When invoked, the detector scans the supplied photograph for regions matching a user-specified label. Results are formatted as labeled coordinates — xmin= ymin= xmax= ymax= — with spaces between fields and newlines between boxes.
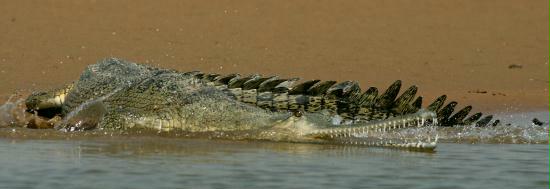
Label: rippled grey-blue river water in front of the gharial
xmin=0 ymin=137 xmax=548 ymax=188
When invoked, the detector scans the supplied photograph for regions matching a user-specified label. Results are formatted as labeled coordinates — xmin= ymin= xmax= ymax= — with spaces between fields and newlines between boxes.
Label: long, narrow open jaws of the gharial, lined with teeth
xmin=294 ymin=111 xmax=438 ymax=151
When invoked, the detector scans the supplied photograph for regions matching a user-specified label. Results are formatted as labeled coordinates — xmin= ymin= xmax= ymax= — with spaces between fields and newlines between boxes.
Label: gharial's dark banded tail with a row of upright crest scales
xmin=201 ymin=74 xmax=498 ymax=126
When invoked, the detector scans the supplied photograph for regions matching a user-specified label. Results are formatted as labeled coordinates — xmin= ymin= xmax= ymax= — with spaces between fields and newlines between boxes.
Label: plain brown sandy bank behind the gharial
xmin=0 ymin=0 xmax=550 ymax=112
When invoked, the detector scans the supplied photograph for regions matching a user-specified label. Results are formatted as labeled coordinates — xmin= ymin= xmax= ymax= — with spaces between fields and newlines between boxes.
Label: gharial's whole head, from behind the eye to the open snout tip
xmin=259 ymin=110 xmax=437 ymax=151
